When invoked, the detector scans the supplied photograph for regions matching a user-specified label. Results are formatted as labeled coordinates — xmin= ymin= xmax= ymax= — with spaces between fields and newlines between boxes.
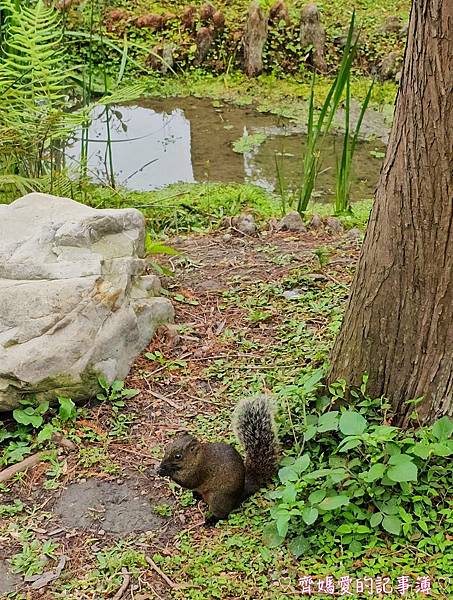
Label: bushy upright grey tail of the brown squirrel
xmin=233 ymin=396 xmax=278 ymax=498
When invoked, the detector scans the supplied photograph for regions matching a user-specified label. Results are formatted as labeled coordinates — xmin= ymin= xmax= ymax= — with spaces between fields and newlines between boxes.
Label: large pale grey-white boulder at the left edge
xmin=0 ymin=194 xmax=173 ymax=410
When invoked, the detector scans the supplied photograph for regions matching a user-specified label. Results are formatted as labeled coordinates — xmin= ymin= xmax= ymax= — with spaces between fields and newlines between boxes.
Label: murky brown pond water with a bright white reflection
xmin=66 ymin=98 xmax=385 ymax=200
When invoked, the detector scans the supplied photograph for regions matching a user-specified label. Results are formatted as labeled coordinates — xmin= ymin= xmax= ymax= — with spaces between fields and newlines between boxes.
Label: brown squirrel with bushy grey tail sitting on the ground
xmin=158 ymin=396 xmax=278 ymax=527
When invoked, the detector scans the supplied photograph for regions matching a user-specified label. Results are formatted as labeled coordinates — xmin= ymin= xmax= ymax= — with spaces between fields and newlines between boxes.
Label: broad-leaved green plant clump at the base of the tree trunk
xmin=266 ymin=375 xmax=453 ymax=551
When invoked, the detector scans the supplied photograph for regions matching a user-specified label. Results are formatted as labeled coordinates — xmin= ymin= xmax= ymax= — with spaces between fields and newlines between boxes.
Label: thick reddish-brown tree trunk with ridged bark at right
xmin=329 ymin=0 xmax=453 ymax=426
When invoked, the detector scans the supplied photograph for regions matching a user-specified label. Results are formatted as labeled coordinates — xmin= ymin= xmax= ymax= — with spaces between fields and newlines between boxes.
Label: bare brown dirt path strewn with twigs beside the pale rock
xmin=0 ymin=229 xmax=360 ymax=600
